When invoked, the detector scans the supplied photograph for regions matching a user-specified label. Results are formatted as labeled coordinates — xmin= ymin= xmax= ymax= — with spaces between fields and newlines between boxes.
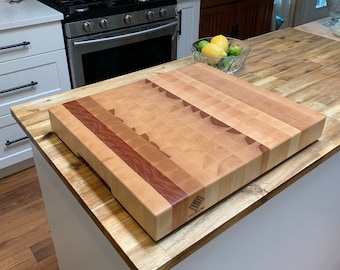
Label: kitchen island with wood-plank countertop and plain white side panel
xmin=12 ymin=28 xmax=340 ymax=269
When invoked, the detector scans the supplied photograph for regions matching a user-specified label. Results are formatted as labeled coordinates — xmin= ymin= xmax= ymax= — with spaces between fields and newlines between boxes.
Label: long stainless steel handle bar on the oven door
xmin=73 ymin=21 xmax=177 ymax=47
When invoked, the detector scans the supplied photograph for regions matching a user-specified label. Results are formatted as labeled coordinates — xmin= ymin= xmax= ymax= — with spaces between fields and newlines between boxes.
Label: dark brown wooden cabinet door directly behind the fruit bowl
xmin=199 ymin=4 xmax=236 ymax=37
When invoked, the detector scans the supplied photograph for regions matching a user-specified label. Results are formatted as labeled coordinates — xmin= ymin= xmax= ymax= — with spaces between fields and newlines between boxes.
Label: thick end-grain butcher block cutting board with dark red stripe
xmin=49 ymin=63 xmax=325 ymax=240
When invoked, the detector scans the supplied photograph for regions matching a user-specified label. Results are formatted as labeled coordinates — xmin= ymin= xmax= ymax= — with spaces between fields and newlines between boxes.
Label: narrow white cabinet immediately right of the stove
xmin=177 ymin=0 xmax=200 ymax=59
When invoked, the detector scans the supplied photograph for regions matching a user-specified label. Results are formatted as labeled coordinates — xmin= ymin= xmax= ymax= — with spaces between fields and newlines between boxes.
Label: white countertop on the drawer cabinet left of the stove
xmin=0 ymin=0 xmax=63 ymax=31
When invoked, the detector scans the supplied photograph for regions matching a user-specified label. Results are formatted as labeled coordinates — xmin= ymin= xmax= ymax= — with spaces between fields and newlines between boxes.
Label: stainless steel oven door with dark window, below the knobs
xmin=66 ymin=18 xmax=177 ymax=88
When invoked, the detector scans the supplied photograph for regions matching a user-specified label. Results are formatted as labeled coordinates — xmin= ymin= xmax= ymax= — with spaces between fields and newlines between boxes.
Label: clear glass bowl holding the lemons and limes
xmin=191 ymin=37 xmax=251 ymax=74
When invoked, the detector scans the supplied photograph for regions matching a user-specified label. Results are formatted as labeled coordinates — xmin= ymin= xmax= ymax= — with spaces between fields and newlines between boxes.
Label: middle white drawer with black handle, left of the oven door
xmin=0 ymin=50 xmax=70 ymax=116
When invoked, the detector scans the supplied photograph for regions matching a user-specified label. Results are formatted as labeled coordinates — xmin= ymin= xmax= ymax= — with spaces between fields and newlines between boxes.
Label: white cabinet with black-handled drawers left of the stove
xmin=0 ymin=21 xmax=71 ymax=178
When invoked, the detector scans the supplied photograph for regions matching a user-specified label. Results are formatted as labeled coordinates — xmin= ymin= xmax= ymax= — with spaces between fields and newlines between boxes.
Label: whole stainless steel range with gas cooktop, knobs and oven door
xmin=40 ymin=0 xmax=177 ymax=88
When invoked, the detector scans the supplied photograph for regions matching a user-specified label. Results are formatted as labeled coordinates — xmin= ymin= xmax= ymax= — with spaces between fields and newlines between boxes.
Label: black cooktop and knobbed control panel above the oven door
xmin=39 ymin=0 xmax=177 ymax=38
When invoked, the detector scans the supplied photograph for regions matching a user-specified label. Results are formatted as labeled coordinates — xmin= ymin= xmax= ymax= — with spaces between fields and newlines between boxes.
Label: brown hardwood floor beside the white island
xmin=0 ymin=167 xmax=58 ymax=270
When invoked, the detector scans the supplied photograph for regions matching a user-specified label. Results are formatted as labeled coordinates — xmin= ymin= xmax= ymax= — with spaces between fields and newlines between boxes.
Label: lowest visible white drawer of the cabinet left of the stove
xmin=0 ymin=115 xmax=32 ymax=169
